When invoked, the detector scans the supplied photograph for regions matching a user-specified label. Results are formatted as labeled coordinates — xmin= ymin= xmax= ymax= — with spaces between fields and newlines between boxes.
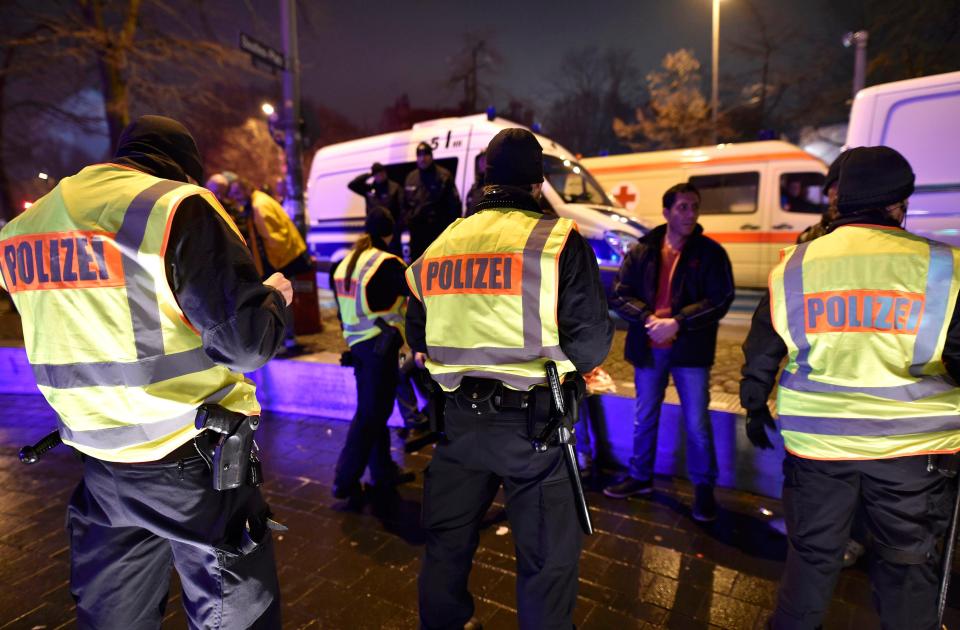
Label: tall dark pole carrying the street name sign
xmin=280 ymin=0 xmax=307 ymax=236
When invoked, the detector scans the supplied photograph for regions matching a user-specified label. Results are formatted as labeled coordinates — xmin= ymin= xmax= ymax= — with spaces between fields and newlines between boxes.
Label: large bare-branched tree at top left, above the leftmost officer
xmin=0 ymin=0 xmax=266 ymax=217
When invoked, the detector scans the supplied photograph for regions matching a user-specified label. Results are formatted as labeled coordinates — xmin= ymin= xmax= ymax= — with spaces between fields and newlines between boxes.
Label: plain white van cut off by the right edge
xmin=847 ymin=72 xmax=960 ymax=247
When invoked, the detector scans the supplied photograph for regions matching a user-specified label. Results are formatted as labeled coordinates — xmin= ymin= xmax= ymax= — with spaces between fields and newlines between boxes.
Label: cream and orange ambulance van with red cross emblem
xmin=582 ymin=140 xmax=827 ymax=288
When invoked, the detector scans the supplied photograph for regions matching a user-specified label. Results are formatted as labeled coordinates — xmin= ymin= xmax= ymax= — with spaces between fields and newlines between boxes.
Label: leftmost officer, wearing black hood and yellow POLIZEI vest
xmin=0 ymin=116 xmax=292 ymax=629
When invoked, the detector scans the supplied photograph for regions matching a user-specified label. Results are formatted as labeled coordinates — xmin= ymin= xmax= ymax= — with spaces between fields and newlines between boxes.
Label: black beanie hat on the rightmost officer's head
xmin=837 ymin=146 xmax=915 ymax=214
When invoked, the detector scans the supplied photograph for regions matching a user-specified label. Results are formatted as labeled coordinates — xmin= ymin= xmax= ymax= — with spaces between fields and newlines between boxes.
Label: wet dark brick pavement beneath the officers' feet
xmin=0 ymin=396 xmax=960 ymax=630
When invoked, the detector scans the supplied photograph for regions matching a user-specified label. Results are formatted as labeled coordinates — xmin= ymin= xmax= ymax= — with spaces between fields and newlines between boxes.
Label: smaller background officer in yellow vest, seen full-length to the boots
xmin=333 ymin=206 xmax=409 ymax=509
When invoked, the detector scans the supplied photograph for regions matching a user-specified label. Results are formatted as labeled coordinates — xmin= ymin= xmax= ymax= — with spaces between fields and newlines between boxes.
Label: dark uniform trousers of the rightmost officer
xmin=771 ymin=454 xmax=954 ymax=630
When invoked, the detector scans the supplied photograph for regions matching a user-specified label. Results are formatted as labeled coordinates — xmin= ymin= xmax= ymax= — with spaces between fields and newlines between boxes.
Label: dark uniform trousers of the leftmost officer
xmin=67 ymin=457 xmax=280 ymax=630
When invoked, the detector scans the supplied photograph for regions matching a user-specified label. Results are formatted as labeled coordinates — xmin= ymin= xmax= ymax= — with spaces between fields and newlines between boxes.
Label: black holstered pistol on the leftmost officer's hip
xmin=194 ymin=405 xmax=263 ymax=491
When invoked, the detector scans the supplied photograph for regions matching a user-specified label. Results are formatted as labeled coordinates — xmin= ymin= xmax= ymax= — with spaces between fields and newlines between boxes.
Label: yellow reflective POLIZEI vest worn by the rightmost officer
xmin=770 ymin=225 xmax=960 ymax=460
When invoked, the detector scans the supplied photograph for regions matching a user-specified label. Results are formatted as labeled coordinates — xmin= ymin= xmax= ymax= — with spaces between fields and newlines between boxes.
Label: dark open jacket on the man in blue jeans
xmin=610 ymin=225 xmax=734 ymax=367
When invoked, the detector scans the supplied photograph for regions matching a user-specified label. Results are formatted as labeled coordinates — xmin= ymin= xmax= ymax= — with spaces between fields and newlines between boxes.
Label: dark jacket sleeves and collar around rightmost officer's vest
xmin=740 ymin=217 xmax=960 ymax=411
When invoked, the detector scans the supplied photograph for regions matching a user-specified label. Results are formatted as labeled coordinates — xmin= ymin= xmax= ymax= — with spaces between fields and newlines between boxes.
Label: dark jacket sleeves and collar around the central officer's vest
xmin=407 ymin=186 xmax=613 ymax=374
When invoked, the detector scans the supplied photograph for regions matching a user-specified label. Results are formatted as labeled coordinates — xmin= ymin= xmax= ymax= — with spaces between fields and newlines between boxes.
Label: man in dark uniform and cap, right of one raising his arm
xmin=403 ymin=142 xmax=461 ymax=262
